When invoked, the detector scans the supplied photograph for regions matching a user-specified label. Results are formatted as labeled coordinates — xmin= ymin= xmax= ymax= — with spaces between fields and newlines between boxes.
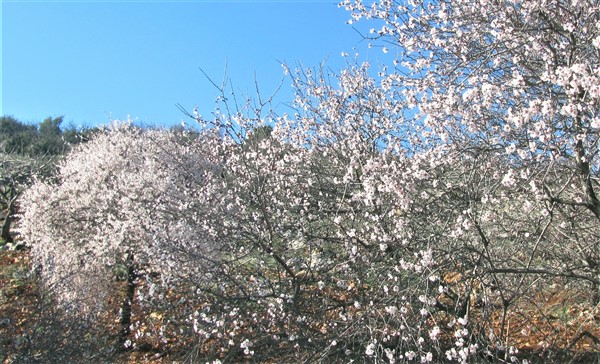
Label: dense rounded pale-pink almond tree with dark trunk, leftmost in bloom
xmin=19 ymin=123 xmax=223 ymax=347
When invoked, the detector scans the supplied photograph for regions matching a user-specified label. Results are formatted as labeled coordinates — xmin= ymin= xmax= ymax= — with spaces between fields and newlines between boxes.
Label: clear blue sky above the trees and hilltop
xmin=0 ymin=0 xmax=381 ymax=129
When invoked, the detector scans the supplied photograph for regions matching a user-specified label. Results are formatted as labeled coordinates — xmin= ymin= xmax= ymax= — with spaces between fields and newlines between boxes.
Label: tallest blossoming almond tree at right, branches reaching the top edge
xmin=341 ymin=0 xmax=600 ymax=356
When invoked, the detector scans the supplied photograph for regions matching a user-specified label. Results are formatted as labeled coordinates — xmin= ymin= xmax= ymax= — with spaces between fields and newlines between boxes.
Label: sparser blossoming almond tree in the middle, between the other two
xmin=176 ymin=67 xmax=477 ymax=361
